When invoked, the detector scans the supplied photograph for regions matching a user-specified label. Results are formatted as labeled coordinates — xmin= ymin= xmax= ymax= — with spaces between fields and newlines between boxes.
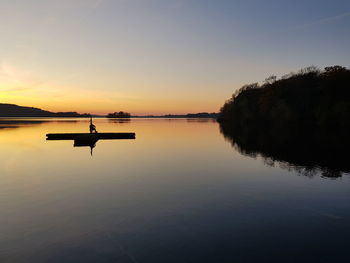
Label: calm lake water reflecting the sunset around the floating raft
xmin=0 ymin=119 xmax=350 ymax=262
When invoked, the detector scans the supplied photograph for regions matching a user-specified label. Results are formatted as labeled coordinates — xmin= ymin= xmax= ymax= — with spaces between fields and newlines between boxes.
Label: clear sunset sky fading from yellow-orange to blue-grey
xmin=0 ymin=0 xmax=350 ymax=115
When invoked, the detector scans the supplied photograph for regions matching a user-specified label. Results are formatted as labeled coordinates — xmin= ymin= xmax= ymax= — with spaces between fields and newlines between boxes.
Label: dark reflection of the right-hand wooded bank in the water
xmin=220 ymin=124 xmax=350 ymax=178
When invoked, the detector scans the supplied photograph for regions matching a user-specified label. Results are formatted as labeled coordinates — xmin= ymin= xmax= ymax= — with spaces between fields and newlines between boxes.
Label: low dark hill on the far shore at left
xmin=0 ymin=103 xmax=90 ymax=117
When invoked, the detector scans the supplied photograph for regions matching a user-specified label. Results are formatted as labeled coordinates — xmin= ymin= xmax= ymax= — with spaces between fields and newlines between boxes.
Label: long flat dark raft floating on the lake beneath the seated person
xmin=46 ymin=132 xmax=135 ymax=141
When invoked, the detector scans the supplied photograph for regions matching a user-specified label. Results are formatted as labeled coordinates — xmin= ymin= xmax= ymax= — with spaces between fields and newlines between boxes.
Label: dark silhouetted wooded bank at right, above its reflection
xmin=218 ymin=66 xmax=350 ymax=136
